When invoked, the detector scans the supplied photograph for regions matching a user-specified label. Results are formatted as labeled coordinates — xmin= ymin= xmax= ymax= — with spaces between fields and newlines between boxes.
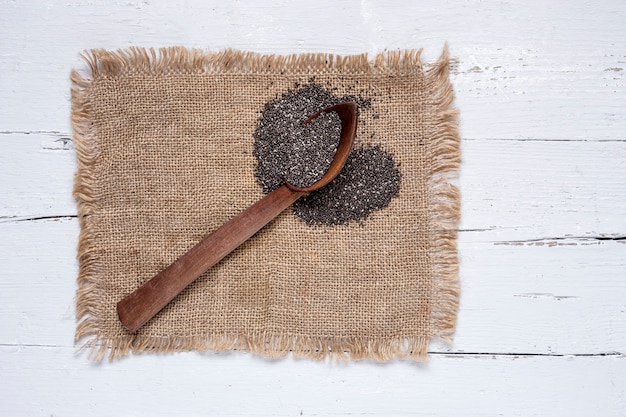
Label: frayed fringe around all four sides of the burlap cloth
xmin=71 ymin=46 xmax=460 ymax=361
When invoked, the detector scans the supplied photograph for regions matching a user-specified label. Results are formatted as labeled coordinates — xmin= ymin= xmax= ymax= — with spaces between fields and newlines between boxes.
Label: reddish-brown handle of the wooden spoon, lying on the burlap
xmin=117 ymin=185 xmax=305 ymax=332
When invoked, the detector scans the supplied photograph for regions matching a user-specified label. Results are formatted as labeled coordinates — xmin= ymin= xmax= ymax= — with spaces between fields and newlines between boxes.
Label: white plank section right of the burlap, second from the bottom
xmin=454 ymin=232 xmax=626 ymax=354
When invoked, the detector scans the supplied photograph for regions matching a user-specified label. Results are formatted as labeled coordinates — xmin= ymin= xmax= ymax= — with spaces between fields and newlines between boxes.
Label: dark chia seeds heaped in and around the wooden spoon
xmin=254 ymin=81 xmax=400 ymax=225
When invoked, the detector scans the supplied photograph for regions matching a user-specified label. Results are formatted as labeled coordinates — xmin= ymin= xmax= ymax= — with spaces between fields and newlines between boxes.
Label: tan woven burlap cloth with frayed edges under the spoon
xmin=72 ymin=44 xmax=459 ymax=360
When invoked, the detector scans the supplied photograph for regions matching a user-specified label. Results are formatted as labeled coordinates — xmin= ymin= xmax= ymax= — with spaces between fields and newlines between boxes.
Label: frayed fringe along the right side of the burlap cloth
xmin=425 ymin=45 xmax=461 ymax=343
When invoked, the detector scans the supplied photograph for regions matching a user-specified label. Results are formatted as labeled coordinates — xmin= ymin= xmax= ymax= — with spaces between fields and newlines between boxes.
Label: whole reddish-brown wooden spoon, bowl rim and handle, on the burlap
xmin=117 ymin=102 xmax=358 ymax=332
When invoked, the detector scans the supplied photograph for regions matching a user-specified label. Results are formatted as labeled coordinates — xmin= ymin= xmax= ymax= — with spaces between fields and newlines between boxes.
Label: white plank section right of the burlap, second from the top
xmin=460 ymin=141 xmax=626 ymax=241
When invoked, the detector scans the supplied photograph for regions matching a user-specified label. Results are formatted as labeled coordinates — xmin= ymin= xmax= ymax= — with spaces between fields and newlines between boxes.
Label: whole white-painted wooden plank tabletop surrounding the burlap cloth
xmin=0 ymin=0 xmax=626 ymax=417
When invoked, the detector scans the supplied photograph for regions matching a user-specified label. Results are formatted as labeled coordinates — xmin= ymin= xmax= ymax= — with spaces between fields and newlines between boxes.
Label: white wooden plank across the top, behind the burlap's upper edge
xmin=0 ymin=0 xmax=626 ymax=141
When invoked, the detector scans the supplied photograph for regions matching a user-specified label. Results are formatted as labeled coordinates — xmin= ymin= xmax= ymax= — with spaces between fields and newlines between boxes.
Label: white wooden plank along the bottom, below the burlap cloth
xmin=0 ymin=346 xmax=626 ymax=417
